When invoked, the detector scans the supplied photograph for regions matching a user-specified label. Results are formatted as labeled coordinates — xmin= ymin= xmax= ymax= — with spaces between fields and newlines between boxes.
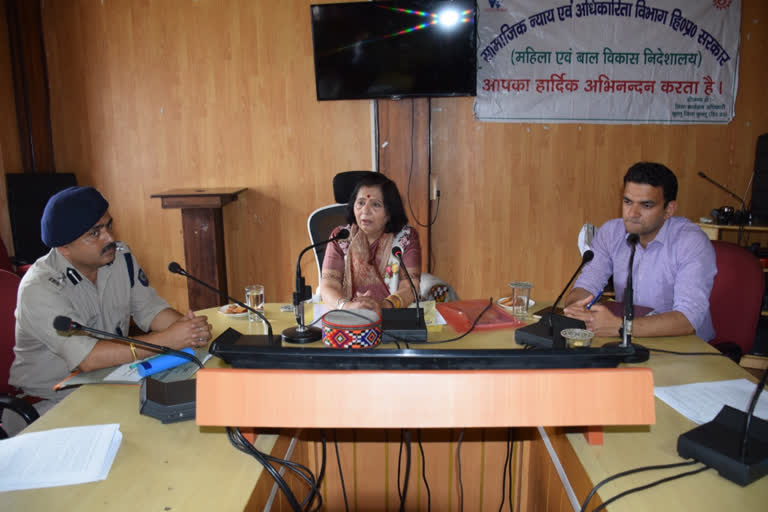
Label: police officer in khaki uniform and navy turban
xmin=9 ymin=187 xmax=211 ymax=418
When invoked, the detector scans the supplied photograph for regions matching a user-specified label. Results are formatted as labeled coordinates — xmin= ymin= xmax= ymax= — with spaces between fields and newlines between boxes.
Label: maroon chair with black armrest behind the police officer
xmin=0 ymin=270 xmax=40 ymax=439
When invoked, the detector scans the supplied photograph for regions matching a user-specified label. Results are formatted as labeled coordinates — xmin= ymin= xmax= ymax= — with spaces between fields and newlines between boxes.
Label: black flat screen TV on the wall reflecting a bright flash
xmin=311 ymin=0 xmax=477 ymax=100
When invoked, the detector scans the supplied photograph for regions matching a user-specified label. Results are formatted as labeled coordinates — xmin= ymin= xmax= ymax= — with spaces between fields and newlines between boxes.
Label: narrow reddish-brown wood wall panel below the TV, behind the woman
xmin=376 ymin=98 xmax=432 ymax=272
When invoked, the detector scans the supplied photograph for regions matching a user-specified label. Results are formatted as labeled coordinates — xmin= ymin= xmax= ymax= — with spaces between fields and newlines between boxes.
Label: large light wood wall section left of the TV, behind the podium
xmin=42 ymin=0 xmax=372 ymax=309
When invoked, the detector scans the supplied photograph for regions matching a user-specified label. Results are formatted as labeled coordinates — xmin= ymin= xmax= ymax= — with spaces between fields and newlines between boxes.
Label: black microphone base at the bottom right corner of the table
xmin=677 ymin=405 xmax=768 ymax=486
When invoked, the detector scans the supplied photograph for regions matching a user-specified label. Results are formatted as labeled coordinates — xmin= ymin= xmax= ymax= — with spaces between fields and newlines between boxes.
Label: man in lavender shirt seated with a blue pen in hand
xmin=565 ymin=162 xmax=717 ymax=341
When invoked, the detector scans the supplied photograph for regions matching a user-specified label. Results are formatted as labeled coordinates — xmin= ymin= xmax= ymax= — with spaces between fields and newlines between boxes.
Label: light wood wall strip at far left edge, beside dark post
xmin=0 ymin=3 xmax=23 ymax=254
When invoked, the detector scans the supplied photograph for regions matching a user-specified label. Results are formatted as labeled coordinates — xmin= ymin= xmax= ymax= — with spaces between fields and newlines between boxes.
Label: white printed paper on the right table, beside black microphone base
xmin=654 ymin=379 xmax=768 ymax=425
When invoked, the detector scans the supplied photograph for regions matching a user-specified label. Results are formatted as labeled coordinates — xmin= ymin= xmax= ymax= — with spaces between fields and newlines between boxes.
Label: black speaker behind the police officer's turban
xmin=6 ymin=173 xmax=77 ymax=264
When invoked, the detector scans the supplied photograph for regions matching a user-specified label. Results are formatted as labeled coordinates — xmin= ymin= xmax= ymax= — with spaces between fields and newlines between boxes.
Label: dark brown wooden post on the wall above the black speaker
xmin=5 ymin=0 xmax=55 ymax=172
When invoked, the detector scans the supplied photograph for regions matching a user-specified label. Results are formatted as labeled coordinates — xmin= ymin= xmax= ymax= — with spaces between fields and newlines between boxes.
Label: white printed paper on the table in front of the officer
xmin=0 ymin=423 xmax=123 ymax=492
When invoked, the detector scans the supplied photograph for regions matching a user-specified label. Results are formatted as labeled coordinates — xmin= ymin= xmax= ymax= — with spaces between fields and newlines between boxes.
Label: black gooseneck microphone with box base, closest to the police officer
xmin=53 ymin=316 xmax=203 ymax=423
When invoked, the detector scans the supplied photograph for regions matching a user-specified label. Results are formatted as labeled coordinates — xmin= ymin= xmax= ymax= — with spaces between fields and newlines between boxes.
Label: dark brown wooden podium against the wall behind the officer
xmin=150 ymin=188 xmax=247 ymax=311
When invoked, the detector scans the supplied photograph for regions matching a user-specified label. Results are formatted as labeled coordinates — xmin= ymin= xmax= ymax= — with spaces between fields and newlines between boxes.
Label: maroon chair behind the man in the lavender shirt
xmin=709 ymin=240 xmax=763 ymax=355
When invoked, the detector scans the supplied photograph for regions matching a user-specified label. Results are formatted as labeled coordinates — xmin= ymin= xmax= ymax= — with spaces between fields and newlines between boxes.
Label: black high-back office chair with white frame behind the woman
xmin=307 ymin=171 xmax=459 ymax=302
